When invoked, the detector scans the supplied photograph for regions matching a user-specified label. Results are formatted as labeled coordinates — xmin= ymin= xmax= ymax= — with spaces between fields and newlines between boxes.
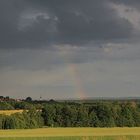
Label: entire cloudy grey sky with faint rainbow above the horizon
xmin=0 ymin=0 xmax=140 ymax=99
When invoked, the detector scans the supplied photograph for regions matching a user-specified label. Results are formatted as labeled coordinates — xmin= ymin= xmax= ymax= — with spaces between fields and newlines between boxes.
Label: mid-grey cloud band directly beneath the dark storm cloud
xmin=0 ymin=42 xmax=140 ymax=71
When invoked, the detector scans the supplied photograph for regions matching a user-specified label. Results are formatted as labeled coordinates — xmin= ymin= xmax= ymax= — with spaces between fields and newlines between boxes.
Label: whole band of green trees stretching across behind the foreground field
xmin=0 ymin=101 xmax=140 ymax=129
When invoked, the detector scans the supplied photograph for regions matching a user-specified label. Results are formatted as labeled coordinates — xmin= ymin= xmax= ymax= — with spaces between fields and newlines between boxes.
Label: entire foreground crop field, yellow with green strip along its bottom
xmin=0 ymin=128 xmax=140 ymax=140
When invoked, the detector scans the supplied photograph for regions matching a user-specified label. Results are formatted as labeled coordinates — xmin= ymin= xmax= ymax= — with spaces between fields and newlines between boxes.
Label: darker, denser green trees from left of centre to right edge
xmin=42 ymin=103 xmax=140 ymax=127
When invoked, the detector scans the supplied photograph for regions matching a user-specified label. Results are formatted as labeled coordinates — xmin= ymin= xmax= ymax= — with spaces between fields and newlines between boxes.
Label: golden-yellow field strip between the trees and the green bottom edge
xmin=0 ymin=128 xmax=140 ymax=137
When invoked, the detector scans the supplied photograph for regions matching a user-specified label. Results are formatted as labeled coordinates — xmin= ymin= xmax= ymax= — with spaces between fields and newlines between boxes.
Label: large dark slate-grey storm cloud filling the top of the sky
xmin=0 ymin=0 xmax=133 ymax=49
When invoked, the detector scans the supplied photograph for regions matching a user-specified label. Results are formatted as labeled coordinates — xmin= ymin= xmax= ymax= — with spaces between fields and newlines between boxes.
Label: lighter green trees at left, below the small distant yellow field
xmin=0 ymin=109 xmax=44 ymax=129
